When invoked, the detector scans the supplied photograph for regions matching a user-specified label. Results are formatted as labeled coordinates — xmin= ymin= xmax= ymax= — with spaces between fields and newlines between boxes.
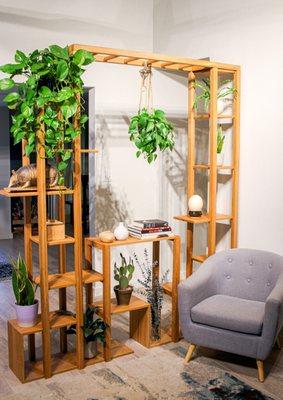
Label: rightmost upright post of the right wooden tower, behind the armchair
xmin=231 ymin=70 xmax=241 ymax=248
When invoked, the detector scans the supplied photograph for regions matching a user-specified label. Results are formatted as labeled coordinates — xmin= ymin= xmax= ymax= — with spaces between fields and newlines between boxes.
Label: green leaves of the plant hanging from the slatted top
xmin=129 ymin=108 xmax=175 ymax=164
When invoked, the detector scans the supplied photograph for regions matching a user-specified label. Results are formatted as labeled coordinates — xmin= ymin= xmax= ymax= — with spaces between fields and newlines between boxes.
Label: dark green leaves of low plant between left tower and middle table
xmin=66 ymin=306 xmax=107 ymax=343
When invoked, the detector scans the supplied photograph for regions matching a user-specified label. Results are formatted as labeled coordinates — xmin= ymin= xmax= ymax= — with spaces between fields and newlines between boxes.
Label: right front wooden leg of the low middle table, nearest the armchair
xmin=172 ymin=236 xmax=181 ymax=342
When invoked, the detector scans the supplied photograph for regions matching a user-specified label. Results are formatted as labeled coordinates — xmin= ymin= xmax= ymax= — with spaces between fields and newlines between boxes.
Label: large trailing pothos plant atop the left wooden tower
xmin=0 ymin=45 xmax=94 ymax=184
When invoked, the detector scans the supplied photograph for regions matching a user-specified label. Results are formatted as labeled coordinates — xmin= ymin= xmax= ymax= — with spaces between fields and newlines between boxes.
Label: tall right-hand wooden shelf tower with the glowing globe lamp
xmin=174 ymin=66 xmax=240 ymax=277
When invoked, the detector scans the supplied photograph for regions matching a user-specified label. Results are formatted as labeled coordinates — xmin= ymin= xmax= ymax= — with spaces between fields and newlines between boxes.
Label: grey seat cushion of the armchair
xmin=191 ymin=294 xmax=265 ymax=335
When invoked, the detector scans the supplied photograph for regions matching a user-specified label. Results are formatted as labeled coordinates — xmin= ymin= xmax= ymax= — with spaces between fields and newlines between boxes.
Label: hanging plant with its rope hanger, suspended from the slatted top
xmin=129 ymin=67 xmax=175 ymax=164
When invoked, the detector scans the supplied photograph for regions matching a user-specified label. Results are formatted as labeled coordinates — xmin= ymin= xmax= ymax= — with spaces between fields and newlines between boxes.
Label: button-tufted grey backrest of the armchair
xmin=206 ymin=249 xmax=283 ymax=301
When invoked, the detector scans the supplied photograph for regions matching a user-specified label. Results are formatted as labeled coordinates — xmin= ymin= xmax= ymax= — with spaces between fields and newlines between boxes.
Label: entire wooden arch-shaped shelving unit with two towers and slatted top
xmin=0 ymin=44 xmax=240 ymax=382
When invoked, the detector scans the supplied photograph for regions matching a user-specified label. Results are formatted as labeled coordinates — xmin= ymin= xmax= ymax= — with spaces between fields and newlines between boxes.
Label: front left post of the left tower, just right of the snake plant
xmin=36 ymin=111 xmax=52 ymax=378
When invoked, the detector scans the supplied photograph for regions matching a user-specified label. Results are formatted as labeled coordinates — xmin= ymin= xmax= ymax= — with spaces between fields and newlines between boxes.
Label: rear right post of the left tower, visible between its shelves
xmin=58 ymin=195 xmax=68 ymax=353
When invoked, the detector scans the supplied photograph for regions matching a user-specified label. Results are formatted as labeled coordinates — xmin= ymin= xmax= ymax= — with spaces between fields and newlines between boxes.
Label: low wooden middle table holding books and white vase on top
xmin=85 ymin=235 xmax=180 ymax=361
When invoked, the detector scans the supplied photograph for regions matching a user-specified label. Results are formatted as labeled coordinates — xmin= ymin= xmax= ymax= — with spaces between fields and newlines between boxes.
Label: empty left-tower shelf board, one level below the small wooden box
xmin=34 ymin=270 xmax=103 ymax=289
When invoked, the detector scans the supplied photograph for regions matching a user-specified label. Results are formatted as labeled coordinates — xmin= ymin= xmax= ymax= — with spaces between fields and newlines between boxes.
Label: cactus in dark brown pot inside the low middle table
xmin=114 ymin=253 xmax=135 ymax=305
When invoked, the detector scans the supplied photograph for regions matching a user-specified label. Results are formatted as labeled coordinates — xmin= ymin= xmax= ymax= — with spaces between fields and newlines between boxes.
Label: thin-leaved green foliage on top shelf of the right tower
xmin=193 ymin=78 xmax=236 ymax=110
